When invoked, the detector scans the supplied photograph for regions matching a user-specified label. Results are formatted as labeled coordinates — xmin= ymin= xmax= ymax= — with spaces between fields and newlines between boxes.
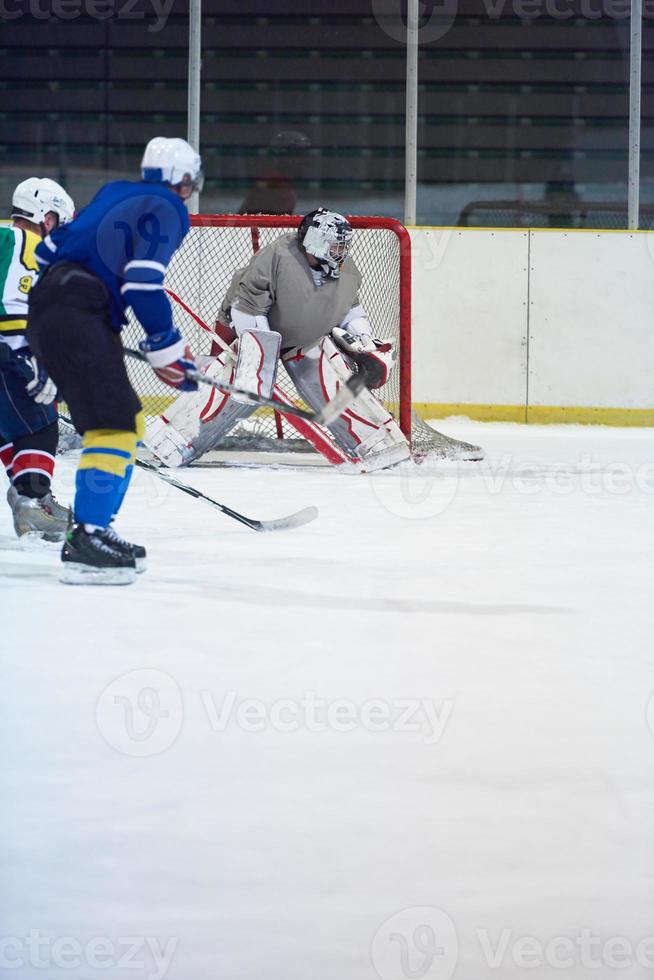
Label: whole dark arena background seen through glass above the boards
xmin=0 ymin=0 xmax=654 ymax=228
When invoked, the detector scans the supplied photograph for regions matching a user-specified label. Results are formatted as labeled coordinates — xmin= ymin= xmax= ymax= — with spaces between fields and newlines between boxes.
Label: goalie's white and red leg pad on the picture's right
xmin=284 ymin=337 xmax=411 ymax=472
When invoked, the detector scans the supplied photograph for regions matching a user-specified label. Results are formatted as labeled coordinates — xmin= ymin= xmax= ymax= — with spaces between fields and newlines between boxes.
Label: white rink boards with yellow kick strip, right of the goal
xmin=411 ymin=228 xmax=654 ymax=425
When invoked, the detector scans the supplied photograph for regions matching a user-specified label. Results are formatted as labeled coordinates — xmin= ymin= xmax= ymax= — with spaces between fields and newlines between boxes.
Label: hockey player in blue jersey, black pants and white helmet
xmin=28 ymin=137 xmax=202 ymax=585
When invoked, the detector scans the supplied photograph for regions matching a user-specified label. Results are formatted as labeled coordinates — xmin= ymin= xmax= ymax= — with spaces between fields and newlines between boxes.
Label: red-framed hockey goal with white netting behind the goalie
xmin=125 ymin=215 xmax=440 ymax=455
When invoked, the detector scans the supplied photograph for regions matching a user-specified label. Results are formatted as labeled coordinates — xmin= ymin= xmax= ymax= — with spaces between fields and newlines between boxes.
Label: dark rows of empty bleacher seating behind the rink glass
xmin=0 ymin=0 xmax=654 ymax=223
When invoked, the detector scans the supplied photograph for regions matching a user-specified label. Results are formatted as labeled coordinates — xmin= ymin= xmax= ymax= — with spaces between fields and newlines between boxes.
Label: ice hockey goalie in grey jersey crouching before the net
xmin=145 ymin=208 xmax=410 ymax=472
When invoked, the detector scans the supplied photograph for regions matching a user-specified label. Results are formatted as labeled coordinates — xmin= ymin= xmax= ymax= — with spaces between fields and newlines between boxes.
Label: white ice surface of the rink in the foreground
xmin=0 ymin=422 xmax=654 ymax=980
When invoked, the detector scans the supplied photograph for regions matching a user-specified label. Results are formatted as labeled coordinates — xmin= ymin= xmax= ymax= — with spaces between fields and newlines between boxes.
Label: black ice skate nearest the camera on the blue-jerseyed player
xmin=59 ymin=524 xmax=136 ymax=585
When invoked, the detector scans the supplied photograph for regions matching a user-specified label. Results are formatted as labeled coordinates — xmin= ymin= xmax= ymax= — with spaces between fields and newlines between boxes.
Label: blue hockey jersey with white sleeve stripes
xmin=35 ymin=180 xmax=189 ymax=334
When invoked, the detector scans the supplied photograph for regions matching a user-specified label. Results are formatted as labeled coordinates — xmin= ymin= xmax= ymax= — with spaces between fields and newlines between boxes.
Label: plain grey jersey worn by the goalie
xmin=220 ymin=233 xmax=361 ymax=348
